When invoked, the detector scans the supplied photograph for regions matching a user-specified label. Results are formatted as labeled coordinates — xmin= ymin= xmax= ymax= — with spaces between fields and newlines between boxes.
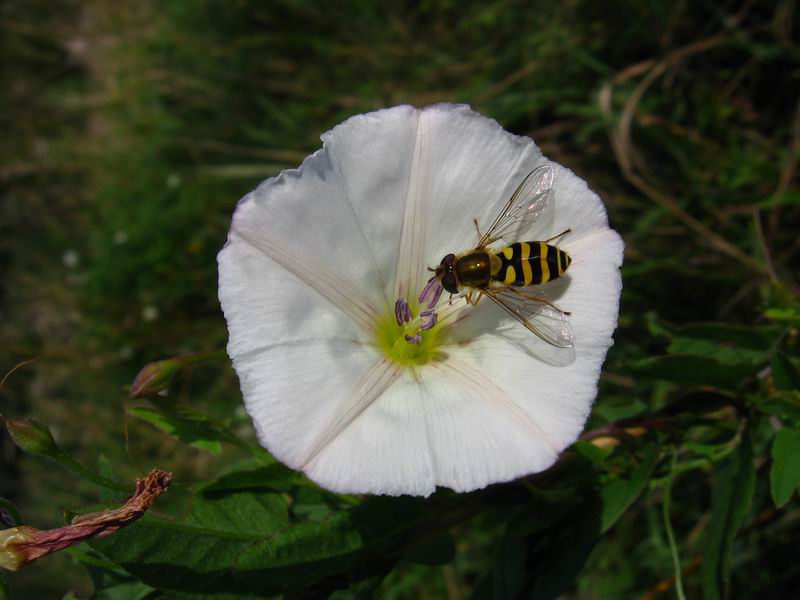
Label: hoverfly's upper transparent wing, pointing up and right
xmin=477 ymin=165 xmax=553 ymax=248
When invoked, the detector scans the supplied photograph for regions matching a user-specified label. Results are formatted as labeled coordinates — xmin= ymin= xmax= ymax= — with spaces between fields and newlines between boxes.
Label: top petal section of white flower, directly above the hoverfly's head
xmin=397 ymin=104 xmax=544 ymax=290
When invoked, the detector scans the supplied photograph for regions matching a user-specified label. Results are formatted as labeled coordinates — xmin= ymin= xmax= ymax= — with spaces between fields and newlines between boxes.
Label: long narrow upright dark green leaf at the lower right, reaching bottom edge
xmin=702 ymin=432 xmax=756 ymax=600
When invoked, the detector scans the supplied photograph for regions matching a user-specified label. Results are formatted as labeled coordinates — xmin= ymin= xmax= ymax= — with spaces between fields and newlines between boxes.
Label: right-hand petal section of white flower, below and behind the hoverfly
xmin=434 ymin=183 xmax=623 ymax=472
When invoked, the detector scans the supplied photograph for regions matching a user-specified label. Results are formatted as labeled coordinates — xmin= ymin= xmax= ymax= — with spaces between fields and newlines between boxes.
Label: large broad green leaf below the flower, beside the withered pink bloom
xmin=90 ymin=470 xmax=435 ymax=598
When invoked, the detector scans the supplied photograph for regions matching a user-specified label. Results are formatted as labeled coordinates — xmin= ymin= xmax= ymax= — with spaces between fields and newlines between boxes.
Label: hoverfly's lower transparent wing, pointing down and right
xmin=482 ymin=288 xmax=575 ymax=348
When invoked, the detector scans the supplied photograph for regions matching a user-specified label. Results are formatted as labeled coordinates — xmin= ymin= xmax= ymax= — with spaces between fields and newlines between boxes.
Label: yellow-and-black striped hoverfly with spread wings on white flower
xmin=428 ymin=165 xmax=573 ymax=348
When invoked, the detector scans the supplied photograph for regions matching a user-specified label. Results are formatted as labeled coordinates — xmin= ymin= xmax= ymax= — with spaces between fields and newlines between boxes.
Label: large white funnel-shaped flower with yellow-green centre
xmin=219 ymin=105 xmax=622 ymax=495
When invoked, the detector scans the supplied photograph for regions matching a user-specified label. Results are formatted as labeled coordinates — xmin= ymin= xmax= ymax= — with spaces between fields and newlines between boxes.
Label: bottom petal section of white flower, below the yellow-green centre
xmin=307 ymin=360 xmax=556 ymax=496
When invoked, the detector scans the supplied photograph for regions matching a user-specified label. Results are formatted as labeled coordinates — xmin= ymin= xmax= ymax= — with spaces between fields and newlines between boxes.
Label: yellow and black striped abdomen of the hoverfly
xmin=491 ymin=242 xmax=572 ymax=286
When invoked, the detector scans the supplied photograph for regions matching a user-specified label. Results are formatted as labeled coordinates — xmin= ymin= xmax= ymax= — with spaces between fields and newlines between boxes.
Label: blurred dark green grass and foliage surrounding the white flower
xmin=0 ymin=0 xmax=800 ymax=598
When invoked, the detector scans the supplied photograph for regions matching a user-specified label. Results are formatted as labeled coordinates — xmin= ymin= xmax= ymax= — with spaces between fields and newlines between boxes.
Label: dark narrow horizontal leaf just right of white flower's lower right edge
xmin=628 ymin=355 xmax=758 ymax=389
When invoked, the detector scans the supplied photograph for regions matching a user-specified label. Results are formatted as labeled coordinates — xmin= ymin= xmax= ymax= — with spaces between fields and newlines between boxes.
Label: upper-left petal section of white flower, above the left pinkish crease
xmin=219 ymin=146 xmax=388 ymax=328
